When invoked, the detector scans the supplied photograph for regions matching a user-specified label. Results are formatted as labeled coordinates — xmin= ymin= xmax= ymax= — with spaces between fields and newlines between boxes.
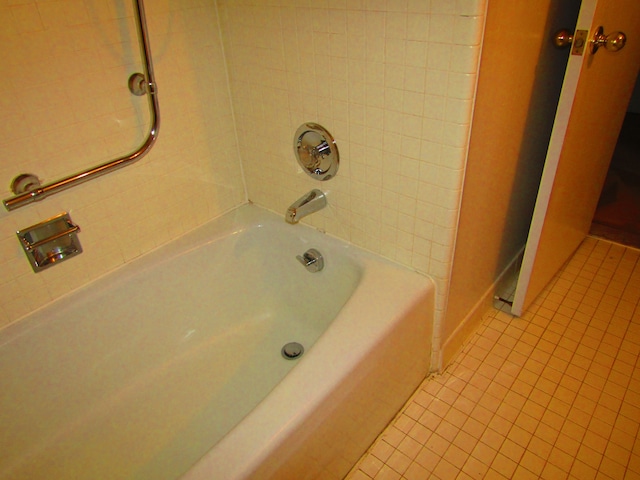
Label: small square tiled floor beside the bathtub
xmin=347 ymin=238 xmax=640 ymax=480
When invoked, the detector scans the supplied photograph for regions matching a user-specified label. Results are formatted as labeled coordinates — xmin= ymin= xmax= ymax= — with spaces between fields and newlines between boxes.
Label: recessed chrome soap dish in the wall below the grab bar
xmin=16 ymin=212 xmax=82 ymax=273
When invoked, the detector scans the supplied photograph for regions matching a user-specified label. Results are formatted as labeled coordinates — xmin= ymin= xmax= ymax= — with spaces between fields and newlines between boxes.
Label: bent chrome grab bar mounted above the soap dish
xmin=2 ymin=0 xmax=160 ymax=211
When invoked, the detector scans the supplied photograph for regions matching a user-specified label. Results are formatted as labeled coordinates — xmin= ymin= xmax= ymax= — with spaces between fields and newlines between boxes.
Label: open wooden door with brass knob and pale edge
xmin=512 ymin=0 xmax=640 ymax=315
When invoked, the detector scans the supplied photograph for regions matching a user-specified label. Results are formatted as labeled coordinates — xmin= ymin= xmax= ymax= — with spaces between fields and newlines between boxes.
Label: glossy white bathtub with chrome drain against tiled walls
xmin=0 ymin=205 xmax=434 ymax=480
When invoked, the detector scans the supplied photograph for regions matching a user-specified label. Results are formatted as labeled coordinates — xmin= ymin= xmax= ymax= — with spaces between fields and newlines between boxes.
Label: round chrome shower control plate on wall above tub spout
xmin=293 ymin=123 xmax=340 ymax=180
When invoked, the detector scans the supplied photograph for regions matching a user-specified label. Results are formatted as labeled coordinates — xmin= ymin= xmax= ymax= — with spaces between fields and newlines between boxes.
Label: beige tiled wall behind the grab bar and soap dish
xmin=0 ymin=0 xmax=246 ymax=326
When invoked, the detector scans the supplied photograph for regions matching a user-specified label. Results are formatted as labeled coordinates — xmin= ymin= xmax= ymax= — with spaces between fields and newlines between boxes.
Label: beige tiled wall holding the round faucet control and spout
xmin=218 ymin=0 xmax=485 ymax=360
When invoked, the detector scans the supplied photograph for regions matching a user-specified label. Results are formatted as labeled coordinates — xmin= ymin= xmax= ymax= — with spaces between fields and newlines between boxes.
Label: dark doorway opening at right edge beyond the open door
xmin=589 ymin=76 xmax=640 ymax=248
